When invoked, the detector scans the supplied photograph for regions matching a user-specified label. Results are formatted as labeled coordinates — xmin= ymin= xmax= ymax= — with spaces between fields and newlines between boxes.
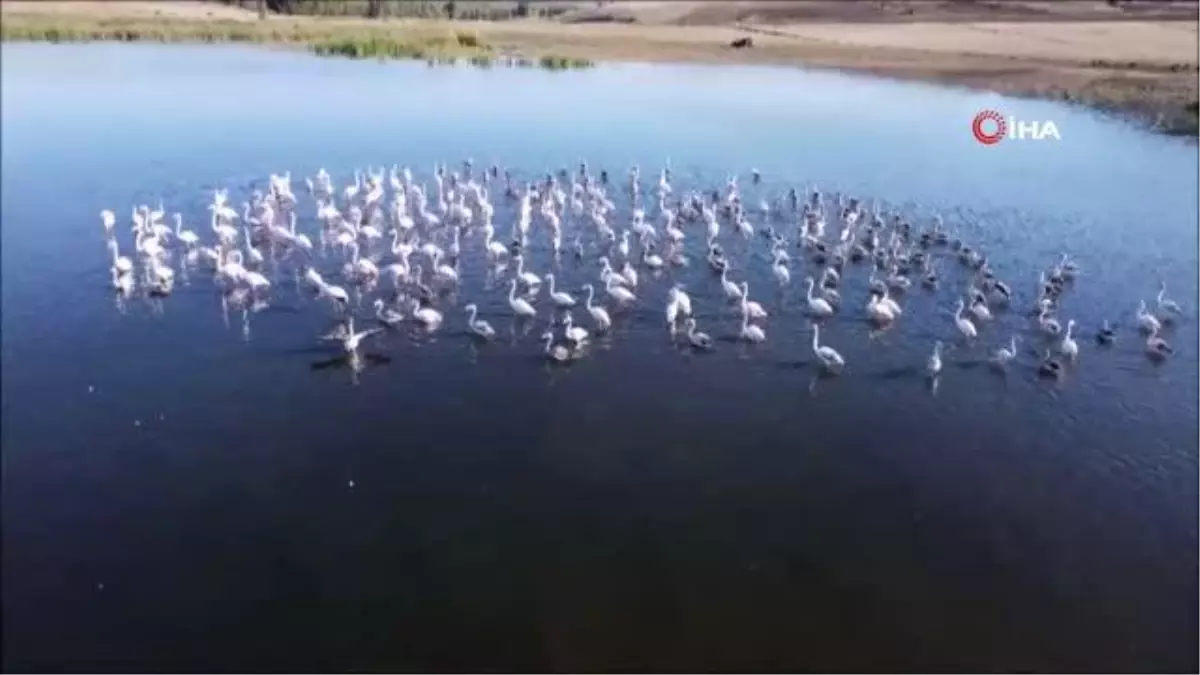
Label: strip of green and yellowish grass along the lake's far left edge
xmin=0 ymin=14 xmax=594 ymax=71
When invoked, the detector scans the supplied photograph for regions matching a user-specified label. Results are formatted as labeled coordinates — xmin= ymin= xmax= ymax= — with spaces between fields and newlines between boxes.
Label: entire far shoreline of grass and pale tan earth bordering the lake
xmin=0 ymin=1 xmax=1200 ymax=137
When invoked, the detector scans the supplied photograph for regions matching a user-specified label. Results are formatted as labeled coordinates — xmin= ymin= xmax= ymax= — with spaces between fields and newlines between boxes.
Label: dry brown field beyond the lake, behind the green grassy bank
xmin=7 ymin=0 xmax=1200 ymax=132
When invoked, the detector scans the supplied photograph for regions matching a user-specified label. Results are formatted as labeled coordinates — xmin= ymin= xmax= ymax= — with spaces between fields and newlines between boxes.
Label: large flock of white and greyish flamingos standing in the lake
xmin=101 ymin=160 xmax=1182 ymax=377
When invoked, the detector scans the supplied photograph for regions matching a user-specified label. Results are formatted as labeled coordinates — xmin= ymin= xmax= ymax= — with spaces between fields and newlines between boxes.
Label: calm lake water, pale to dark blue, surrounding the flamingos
xmin=0 ymin=44 xmax=1198 ymax=671
